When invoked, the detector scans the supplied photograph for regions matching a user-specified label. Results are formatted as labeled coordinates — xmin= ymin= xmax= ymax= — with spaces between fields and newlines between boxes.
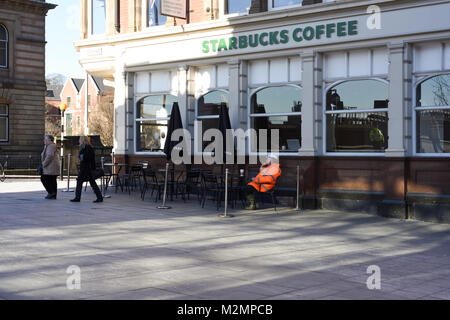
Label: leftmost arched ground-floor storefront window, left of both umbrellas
xmin=136 ymin=94 xmax=178 ymax=152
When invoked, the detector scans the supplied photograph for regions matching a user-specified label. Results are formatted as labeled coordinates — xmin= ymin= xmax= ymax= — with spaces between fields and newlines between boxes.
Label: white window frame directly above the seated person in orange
xmin=247 ymin=82 xmax=303 ymax=156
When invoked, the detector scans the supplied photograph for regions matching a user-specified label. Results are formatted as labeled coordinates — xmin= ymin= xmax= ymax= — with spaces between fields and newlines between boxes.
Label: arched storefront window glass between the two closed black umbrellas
xmin=197 ymin=90 xmax=230 ymax=149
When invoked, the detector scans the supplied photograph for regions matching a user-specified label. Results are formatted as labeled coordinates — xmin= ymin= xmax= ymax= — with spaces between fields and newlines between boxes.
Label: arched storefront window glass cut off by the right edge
xmin=415 ymin=74 xmax=450 ymax=153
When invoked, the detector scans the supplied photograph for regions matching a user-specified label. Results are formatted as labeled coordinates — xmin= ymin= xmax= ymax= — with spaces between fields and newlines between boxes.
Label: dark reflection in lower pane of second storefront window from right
xmin=327 ymin=112 xmax=388 ymax=152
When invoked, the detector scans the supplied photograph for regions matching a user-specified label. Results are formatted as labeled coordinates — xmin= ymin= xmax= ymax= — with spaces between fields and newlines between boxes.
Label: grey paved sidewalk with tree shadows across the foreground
xmin=0 ymin=180 xmax=450 ymax=300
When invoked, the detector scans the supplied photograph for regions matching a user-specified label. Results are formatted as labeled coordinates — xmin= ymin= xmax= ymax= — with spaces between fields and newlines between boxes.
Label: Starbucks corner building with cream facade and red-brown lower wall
xmin=75 ymin=0 xmax=450 ymax=222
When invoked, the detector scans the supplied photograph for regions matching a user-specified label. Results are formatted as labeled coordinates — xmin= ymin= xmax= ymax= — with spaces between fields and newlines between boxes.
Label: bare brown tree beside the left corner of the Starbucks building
xmin=89 ymin=94 xmax=114 ymax=146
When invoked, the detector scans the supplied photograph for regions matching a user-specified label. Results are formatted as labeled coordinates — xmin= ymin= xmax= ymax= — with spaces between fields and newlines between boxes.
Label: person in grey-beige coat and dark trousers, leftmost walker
xmin=41 ymin=134 xmax=59 ymax=199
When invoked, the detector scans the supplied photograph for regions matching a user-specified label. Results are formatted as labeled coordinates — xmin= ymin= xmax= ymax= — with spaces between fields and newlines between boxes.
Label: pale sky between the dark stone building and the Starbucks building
xmin=45 ymin=0 xmax=85 ymax=78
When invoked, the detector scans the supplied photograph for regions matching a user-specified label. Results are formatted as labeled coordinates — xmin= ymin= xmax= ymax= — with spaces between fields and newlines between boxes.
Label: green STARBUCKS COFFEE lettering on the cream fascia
xmin=202 ymin=20 xmax=358 ymax=53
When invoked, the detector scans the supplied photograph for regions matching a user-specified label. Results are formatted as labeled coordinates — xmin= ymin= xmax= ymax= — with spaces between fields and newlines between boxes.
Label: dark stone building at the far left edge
xmin=0 ymin=0 xmax=56 ymax=157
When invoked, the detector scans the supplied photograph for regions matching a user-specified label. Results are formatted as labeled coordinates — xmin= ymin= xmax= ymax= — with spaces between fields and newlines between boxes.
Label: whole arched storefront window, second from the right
xmin=325 ymin=80 xmax=389 ymax=152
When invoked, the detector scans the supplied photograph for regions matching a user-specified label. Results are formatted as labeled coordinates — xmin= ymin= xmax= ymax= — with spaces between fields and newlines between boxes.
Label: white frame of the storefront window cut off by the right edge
xmin=411 ymin=71 xmax=450 ymax=158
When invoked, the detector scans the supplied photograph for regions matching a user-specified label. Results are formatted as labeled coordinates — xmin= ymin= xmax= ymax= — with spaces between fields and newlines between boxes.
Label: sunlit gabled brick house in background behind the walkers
xmin=60 ymin=75 xmax=114 ymax=136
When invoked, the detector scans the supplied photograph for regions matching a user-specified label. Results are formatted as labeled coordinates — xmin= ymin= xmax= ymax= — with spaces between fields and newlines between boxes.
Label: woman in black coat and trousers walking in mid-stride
xmin=70 ymin=136 xmax=103 ymax=202
